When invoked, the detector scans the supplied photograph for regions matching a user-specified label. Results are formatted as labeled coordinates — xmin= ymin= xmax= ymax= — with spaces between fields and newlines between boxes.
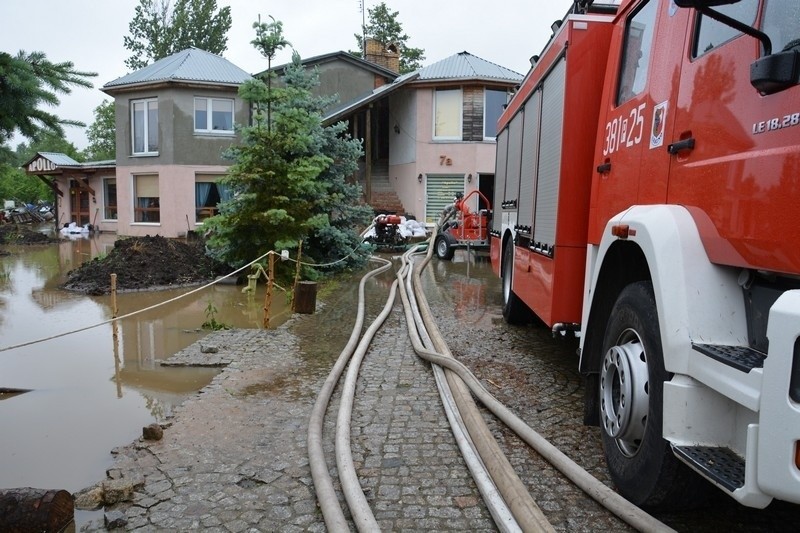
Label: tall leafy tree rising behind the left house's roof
xmin=123 ymin=0 xmax=231 ymax=70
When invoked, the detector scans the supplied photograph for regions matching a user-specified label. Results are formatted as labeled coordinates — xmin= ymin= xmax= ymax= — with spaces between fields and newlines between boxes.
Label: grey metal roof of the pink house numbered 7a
xmin=323 ymin=52 xmax=523 ymax=124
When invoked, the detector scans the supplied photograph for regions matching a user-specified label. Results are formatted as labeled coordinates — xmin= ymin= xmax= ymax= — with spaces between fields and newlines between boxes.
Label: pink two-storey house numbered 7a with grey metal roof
xmin=325 ymin=52 xmax=522 ymax=223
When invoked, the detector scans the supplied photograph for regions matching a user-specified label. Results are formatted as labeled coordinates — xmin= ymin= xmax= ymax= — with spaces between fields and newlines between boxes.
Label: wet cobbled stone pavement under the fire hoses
xmin=80 ymin=252 xmax=800 ymax=531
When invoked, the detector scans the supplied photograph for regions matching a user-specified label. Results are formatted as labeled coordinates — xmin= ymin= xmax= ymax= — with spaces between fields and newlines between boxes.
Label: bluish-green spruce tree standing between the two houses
xmin=204 ymin=20 xmax=371 ymax=275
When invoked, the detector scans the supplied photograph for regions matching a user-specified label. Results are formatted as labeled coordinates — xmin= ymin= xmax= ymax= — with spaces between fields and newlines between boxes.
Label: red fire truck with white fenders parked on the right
xmin=490 ymin=0 xmax=800 ymax=509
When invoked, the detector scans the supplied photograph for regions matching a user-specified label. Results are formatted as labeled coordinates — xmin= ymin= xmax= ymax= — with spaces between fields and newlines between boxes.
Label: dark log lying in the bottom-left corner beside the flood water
xmin=0 ymin=487 xmax=75 ymax=533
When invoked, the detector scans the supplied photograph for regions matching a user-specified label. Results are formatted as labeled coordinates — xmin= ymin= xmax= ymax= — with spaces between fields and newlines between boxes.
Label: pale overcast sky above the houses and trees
xmin=0 ymin=0 xmax=572 ymax=149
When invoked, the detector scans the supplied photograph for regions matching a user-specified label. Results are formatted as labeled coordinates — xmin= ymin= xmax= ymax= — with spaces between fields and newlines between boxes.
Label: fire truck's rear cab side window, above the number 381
xmin=617 ymin=2 xmax=658 ymax=105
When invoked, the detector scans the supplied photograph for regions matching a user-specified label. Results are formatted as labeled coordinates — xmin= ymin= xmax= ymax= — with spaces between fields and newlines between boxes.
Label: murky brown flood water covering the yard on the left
xmin=0 ymin=228 xmax=288 ymax=492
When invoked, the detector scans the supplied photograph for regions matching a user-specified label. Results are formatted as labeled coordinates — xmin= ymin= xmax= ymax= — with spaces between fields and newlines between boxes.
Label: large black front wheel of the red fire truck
xmin=598 ymin=282 xmax=709 ymax=510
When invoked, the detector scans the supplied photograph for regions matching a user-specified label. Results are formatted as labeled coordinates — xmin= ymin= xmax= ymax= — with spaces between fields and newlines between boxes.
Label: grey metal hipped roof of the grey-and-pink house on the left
xmin=103 ymin=47 xmax=252 ymax=92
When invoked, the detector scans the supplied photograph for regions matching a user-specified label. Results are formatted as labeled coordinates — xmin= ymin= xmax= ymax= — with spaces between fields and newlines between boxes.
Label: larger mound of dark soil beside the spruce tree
xmin=64 ymin=236 xmax=230 ymax=295
